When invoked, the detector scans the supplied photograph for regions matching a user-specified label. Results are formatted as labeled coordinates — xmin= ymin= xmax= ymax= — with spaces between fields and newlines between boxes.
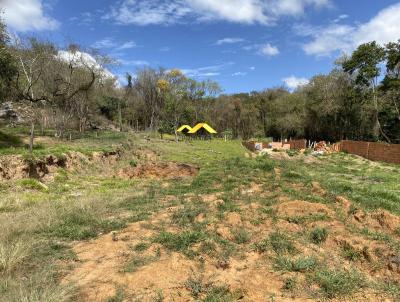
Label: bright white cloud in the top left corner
xmin=0 ymin=0 xmax=59 ymax=32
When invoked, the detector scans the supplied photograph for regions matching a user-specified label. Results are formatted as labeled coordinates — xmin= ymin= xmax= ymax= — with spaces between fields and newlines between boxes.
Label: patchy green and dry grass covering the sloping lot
xmin=0 ymin=129 xmax=400 ymax=302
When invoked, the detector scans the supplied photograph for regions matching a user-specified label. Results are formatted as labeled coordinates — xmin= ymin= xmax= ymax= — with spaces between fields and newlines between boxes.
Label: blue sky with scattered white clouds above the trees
xmin=0 ymin=0 xmax=400 ymax=93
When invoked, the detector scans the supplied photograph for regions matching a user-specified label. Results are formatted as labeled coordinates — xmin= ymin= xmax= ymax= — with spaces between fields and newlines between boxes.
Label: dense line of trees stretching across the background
xmin=0 ymin=22 xmax=400 ymax=143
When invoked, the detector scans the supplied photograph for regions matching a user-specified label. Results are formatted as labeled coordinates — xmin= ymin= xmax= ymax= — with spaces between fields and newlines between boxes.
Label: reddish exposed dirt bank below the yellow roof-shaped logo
xmin=117 ymin=162 xmax=199 ymax=179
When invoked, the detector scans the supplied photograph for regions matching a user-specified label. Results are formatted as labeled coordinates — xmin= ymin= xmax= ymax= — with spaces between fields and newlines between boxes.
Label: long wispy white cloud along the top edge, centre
xmin=104 ymin=0 xmax=330 ymax=25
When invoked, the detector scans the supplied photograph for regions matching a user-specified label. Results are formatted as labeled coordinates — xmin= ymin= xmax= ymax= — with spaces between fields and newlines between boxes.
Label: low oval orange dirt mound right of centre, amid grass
xmin=276 ymin=200 xmax=334 ymax=217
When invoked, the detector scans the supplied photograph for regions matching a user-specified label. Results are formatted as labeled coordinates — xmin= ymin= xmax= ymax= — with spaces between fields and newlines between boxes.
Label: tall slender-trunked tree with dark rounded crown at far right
xmin=343 ymin=41 xmax=390 ymax=142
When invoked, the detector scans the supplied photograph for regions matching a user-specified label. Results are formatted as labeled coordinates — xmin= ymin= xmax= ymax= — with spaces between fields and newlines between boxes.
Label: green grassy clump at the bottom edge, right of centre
xmin=314 ymin=269 xmax=365 ymax=299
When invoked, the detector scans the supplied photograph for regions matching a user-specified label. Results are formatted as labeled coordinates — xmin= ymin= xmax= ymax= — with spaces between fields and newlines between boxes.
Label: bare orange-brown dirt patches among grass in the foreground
xmin=64 ymin=180 xmax=400 ymax=302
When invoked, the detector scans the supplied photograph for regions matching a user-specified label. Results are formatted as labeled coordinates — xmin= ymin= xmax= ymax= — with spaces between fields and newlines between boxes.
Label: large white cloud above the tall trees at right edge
xmin=296 ymin=3 xmax=400 ymax=56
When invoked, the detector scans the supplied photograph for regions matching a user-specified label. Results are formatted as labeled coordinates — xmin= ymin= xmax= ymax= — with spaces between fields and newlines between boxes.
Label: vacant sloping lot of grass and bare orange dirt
xmin=0 ymin=131 xmax=400 ymax=302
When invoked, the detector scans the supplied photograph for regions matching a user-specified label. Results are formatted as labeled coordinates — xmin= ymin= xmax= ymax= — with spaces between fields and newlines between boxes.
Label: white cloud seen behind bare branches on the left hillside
xmin=57 ymin=50 xmax=115 ymax=78
